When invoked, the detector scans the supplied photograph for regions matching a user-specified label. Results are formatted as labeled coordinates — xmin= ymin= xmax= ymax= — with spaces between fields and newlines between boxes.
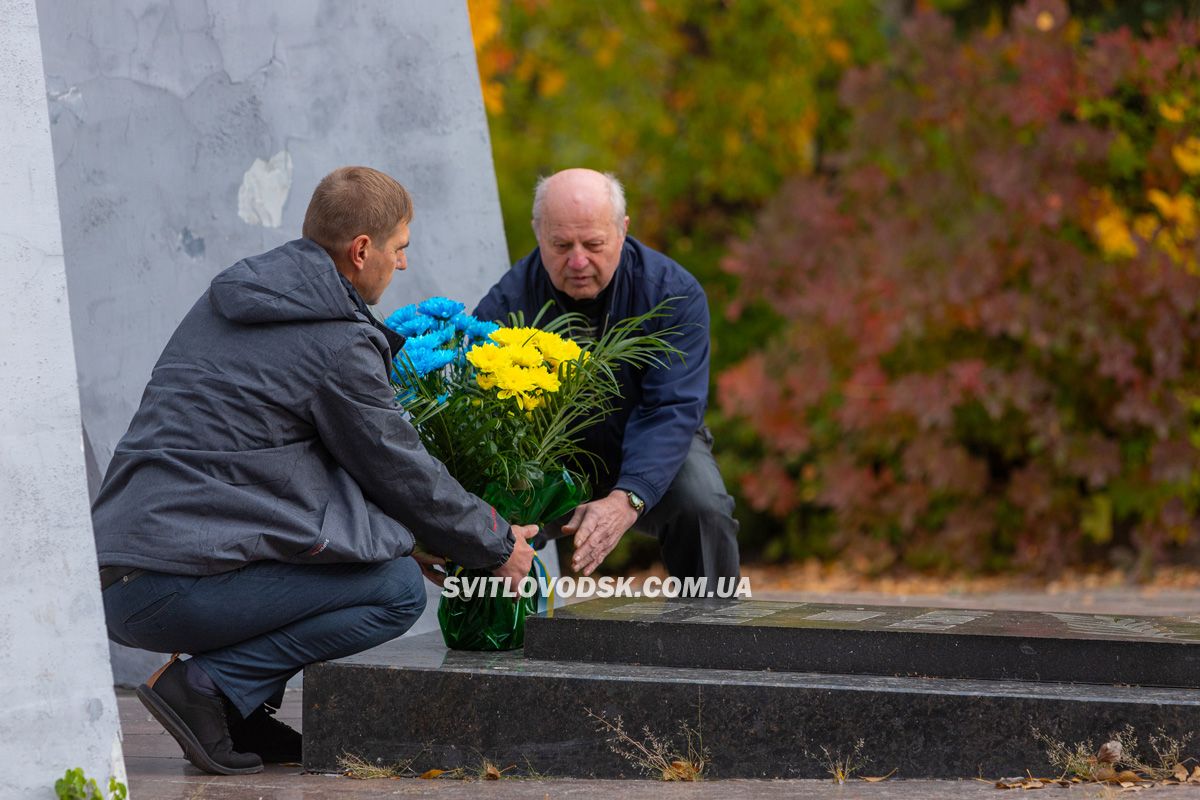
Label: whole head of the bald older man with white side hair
xmin=533 ymin=169 xmax=629 ymax=300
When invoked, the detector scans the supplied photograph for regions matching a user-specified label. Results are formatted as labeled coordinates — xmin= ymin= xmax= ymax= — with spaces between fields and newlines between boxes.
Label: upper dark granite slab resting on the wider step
xmin=526 ymin=599 xmax=1200 ymax=688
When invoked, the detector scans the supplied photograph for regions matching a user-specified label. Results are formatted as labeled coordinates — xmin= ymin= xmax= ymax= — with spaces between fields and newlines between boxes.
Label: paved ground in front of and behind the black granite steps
xmin=118 ymin=587 xmax=1200 ymax=800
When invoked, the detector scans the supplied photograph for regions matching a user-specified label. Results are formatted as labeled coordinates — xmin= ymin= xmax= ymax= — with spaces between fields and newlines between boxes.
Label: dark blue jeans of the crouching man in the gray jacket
xmin=103 ymin=558 xmax=425 ymax=717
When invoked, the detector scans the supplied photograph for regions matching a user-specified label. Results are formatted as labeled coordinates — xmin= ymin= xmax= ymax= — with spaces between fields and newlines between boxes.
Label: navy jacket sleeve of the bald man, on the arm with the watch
xmin=614 ymin=288 xmax=709 ymax=510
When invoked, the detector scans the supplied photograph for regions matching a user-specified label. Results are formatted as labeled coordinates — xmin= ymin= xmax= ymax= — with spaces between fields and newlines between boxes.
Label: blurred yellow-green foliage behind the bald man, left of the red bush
xmin=468 ymin=0 xmax=882 ymax=262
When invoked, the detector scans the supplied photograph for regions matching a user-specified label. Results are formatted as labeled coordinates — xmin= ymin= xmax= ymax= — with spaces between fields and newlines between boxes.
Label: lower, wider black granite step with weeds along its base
xmin=304 ymin=627 xmax=1200 ymax=778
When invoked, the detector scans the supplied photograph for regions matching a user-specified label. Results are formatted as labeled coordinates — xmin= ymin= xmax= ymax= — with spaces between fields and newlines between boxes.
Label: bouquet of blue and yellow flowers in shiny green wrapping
xmin=385 ymin=297 xmax=683 ymax=650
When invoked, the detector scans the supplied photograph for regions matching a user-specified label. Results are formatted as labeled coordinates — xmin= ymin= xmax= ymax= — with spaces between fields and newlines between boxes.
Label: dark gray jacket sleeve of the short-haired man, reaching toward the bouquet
xmin=312 ymin=327 xmax=514 ymax=570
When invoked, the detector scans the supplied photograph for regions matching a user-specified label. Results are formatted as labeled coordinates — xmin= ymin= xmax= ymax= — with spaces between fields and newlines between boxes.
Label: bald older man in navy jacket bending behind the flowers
xmin=475 ymin=169 xmax=739 ymax=589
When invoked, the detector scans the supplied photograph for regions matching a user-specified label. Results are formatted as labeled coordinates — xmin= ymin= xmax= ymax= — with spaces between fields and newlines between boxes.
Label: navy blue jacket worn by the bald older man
xmin=474 ymin=236 xmax=709 ymax=509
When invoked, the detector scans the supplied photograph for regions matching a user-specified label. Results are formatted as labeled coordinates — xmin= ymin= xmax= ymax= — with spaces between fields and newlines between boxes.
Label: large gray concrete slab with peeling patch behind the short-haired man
xmin=38 ymin=0 xmax=557 ymax=684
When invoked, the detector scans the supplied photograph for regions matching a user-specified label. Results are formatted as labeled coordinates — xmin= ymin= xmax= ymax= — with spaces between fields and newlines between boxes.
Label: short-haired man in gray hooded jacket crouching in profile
xmin=92 ymin=167 xmax=536 ymax=775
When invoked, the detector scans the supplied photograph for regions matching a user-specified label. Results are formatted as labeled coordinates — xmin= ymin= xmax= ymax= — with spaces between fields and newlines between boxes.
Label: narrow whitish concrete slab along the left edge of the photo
xmin=0 ymin=0 xmax=124 ymax=799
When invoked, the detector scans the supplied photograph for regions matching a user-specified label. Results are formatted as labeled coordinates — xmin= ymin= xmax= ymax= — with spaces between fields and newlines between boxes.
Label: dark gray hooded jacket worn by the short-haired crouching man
xmin=92 ymin=239 xmax=514 ymax=575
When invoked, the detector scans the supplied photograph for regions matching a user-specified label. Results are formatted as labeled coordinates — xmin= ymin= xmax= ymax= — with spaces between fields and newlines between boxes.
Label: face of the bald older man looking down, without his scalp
xmin=536 ymin=194 xmax=629 ymax=300
